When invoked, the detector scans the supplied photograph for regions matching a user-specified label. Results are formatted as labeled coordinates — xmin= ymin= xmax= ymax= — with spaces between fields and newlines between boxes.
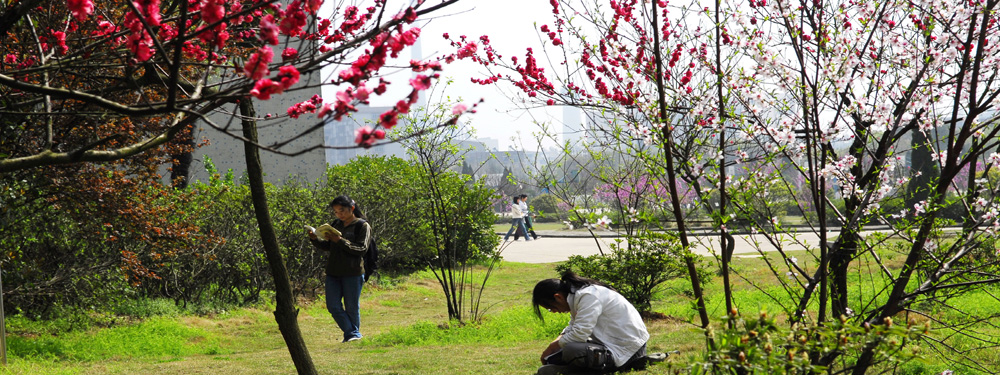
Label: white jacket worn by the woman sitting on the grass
xmin=559 ymin=285 xmax=649 ymax=366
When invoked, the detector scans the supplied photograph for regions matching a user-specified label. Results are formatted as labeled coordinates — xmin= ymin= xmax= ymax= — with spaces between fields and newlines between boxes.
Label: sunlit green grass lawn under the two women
xmin=0 ymin=256 xmax=1000 ymax=375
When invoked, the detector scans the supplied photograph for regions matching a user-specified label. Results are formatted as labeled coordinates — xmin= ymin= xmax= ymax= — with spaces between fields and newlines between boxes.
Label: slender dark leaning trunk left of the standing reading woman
xmin=240 ymin=97 xmax=316 ymax=375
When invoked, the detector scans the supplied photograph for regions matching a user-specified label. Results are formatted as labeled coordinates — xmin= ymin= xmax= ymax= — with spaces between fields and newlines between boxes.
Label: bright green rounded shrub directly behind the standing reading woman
xmin=326 ymin=156 xmax=496 ymax=274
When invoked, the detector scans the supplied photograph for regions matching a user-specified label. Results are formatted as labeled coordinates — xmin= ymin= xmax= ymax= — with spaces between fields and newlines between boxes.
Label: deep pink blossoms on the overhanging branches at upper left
xmin=53 ymin=0 xmax=472 ymax=150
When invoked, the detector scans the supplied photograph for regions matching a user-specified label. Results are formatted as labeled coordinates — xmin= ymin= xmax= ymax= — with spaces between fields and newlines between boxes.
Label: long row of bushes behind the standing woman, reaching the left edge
xmin=0 ymin=157 xmax=497 ymax=319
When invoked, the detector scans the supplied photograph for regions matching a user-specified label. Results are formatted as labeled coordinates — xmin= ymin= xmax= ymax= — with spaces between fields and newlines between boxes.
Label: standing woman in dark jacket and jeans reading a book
xmin=309 ymin=195 xmax=372 ymax=342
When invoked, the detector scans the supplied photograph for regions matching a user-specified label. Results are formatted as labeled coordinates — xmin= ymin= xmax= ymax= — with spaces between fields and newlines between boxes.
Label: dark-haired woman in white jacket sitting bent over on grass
xmin=531 ymin=272 xmax=649 ymax=375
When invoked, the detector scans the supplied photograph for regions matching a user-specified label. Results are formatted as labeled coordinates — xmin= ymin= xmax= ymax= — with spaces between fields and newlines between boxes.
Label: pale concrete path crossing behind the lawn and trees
xmin=500 ymin=231 xmax=835 ymax=263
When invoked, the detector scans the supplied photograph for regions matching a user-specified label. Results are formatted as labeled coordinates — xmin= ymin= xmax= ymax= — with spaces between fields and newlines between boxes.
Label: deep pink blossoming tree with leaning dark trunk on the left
xmin=0 ymin=0 xmax=475 ymax=374
